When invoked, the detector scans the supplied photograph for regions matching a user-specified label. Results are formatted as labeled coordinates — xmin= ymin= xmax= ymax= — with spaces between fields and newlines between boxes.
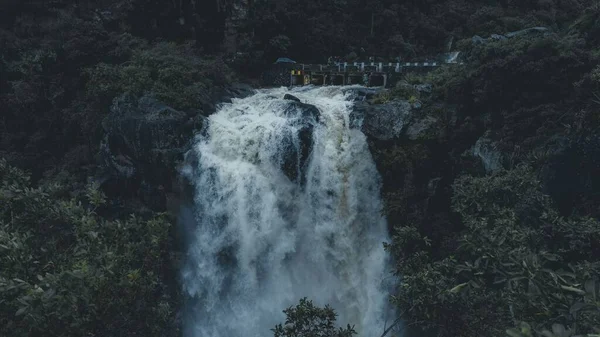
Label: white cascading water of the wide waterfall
xmin=183 ymin=87 xmax=390 ymax=337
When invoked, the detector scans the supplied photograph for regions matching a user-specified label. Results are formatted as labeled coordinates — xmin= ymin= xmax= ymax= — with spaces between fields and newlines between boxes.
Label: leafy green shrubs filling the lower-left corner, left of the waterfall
xmin=0 ymin=160 xmax=177 ymax=336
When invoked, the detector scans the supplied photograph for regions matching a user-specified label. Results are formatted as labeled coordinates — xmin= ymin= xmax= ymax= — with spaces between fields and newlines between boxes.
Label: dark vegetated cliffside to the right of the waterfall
xmin=373 ymin=3 xmax=600 ymax=336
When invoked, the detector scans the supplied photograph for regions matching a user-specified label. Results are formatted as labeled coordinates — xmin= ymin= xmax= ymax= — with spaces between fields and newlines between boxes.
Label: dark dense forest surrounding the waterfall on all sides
xmin=0 ymin=0 xmax=600 ymax=337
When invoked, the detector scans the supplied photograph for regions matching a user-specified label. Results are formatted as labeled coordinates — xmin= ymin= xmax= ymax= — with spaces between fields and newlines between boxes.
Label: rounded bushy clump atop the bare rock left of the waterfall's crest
xmin=86 ymin=42 xmax=233 ymax=109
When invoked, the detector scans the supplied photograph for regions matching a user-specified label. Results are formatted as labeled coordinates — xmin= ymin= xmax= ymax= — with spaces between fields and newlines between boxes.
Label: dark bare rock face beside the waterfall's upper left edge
xmin=97 ymin=85 xmax=252 ymax=211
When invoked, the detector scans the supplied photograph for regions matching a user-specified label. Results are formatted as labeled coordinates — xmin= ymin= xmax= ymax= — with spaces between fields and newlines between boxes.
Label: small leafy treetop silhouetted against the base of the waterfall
xmin=272 ymin=298 xmax=356 ymax=337
